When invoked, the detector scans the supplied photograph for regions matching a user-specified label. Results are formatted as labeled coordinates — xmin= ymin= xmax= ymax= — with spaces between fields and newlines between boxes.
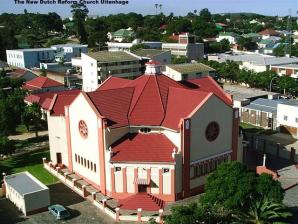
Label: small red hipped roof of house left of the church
xmin=23 ymin=76 xmax=64 ymax=90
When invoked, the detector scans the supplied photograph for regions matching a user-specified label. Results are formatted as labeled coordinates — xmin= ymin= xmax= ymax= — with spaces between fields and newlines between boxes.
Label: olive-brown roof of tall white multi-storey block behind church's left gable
xmin=88 ymin=51 xmax=139 ymax=63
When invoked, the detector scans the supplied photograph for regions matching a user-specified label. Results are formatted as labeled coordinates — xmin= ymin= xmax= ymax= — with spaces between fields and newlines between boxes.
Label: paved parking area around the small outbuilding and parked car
xmin=0 ymin=183 xmax=115 ymax=224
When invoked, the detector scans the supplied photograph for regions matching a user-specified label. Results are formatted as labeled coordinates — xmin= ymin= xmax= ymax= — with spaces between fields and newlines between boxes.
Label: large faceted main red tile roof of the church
xmin=87 ymin=74 xmax=232 ymax=130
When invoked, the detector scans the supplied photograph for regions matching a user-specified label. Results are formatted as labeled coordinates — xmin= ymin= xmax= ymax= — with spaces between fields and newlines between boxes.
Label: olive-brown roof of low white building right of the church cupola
xmin=166 ymin=63 xmax=215 ymax=73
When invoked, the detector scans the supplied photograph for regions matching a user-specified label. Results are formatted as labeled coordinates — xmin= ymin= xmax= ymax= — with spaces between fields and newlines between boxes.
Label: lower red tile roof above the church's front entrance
xmin=111 ymin=133 xmax=176 ymax=163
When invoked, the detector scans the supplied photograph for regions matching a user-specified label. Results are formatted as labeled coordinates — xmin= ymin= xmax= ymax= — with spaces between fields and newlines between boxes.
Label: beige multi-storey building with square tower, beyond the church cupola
xmin=162 ymin=33 xmax=204 ymax=60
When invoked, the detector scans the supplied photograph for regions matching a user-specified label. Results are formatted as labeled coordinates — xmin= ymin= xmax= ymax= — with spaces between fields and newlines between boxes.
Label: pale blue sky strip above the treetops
xmin=0 ymin=0 xmax=298 ymax=18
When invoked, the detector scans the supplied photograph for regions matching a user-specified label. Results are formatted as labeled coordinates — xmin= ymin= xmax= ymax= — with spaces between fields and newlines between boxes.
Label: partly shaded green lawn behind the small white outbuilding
xmin=0 ymin=150 xmax=58 ymax=185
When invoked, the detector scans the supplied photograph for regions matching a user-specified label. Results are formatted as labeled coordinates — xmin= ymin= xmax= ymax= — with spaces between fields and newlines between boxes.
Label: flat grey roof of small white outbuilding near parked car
xmin=4 ymin=171 xmax=48 ymax=195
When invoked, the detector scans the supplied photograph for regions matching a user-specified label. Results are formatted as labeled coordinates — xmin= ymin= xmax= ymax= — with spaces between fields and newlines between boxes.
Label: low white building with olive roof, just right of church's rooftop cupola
xmin=164 ymin=63 xmax=215 ymax=81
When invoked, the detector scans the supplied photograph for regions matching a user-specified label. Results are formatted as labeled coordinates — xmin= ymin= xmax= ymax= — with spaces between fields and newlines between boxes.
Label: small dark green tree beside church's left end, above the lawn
xmin=22 ymin=103 xmax=42 ymax=137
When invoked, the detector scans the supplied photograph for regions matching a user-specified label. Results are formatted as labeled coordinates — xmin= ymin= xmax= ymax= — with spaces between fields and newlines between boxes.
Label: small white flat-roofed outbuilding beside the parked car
xmin=4 ymin=171 xmax=50 ymax=216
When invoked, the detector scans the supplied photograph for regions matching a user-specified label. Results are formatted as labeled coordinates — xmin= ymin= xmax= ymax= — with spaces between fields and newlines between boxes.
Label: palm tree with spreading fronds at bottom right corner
xmin=232 ymin=198 xmax=292 ymax=224
